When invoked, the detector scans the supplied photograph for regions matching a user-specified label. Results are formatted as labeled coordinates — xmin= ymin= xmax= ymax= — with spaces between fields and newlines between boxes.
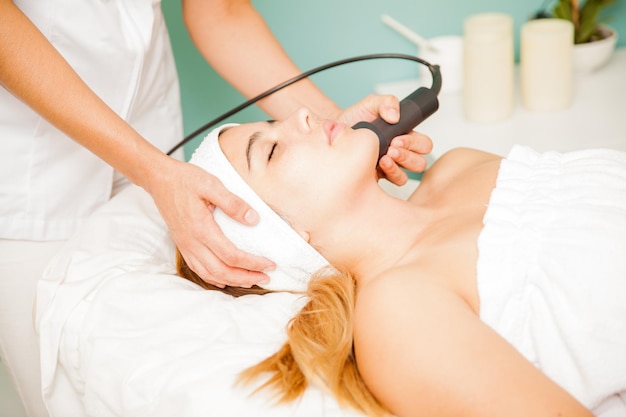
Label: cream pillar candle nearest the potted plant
xmin=520 ymin=19 xmax=574 ymax=111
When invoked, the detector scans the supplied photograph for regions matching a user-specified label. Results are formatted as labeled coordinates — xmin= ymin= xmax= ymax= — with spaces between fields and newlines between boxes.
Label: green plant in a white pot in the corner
xmin=537 ymin=0 xmax=619 ymax=72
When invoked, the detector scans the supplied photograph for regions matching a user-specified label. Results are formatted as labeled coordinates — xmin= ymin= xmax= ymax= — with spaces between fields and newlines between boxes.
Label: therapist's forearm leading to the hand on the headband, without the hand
xmin=0 ymin=0 xmax=170 ymax=188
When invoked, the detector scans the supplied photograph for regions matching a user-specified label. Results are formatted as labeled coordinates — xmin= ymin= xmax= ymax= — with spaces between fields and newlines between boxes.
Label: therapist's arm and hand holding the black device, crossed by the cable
xmin=183 ymin=0 xmax=432 ymax=184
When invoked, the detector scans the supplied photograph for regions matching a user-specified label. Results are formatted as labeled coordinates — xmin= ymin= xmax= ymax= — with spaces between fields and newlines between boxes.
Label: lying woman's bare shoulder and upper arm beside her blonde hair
xmin=354 ymin=268 xmax=591 ymax=417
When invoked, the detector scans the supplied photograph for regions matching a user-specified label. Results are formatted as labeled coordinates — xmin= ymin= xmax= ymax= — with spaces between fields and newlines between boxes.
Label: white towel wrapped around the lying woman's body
xmin=477 ymin=146 xmax=626 ymax=416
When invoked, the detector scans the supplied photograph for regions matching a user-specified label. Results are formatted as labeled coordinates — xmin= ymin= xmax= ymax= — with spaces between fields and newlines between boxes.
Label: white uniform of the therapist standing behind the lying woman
xmin=0 ymin=0 xmax=182 ymax=416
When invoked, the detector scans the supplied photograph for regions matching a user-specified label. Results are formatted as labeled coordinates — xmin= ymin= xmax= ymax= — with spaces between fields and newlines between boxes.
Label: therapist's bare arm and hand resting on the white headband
xmin=0 ymin=0 xmax=273 ymax=286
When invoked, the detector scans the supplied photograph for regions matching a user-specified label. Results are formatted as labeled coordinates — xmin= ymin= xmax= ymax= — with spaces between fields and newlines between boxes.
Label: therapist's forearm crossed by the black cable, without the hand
xmin=183 ymin=0 xmax=340 ymax=119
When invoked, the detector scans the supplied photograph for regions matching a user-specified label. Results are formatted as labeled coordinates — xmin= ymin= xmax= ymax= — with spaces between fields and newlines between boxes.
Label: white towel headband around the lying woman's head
xmin=189 ymin=124 xmax=329 ymax=291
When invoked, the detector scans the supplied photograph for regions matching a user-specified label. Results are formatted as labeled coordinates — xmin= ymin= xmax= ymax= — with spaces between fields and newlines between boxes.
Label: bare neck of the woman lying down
xmin=312 ymin=186 xmax=429 ymax=282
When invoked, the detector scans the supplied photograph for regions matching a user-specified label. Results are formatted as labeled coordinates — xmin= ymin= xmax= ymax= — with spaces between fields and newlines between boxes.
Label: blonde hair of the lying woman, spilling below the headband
xmin=176 ymin=250 xmax=390 ymax=416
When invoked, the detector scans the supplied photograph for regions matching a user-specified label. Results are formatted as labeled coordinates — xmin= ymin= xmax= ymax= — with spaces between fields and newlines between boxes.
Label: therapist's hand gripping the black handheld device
xmin=339 ymin=95 xmax=433 ymax=185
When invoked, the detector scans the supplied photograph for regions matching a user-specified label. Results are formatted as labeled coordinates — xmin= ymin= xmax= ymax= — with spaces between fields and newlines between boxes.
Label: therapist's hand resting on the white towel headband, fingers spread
xmin=148 ymin=159 xmax=274 ymax=288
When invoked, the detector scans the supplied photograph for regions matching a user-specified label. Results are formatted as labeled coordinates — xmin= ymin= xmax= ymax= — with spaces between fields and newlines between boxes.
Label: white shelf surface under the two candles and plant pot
xmin=375 ymin=48 xmax=626 ymax=166
